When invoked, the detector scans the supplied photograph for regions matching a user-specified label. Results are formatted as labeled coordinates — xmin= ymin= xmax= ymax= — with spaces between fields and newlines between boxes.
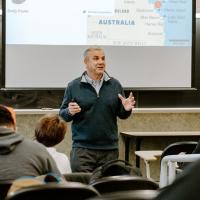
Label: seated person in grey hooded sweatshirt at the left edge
xmin=0 ymin=105 xmax=60 ymax=181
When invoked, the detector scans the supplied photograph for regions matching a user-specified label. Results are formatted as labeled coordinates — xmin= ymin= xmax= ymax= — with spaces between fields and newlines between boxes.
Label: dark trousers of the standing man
xmin=70 ymin=148 xmax=119 ymax=172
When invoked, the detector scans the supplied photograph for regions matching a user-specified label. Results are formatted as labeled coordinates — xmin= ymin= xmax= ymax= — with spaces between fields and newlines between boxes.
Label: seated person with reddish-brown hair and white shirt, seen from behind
xmin=35 ymin=115 xmax=71 ymax=174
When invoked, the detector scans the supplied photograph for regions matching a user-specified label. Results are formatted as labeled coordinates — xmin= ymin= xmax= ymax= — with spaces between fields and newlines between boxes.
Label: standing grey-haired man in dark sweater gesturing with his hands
xmin=60 ymin=48 xmax=135 ymax=172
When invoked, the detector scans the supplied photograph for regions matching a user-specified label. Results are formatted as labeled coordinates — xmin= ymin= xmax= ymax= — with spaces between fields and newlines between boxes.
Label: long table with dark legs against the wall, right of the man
xmin=120 ymin=131 xmax=200 ymax=167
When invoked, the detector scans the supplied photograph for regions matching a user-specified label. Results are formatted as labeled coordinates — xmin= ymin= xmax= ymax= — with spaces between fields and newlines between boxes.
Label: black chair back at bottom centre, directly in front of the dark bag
xmin=91 ymin=175 xmax=159 ymax=194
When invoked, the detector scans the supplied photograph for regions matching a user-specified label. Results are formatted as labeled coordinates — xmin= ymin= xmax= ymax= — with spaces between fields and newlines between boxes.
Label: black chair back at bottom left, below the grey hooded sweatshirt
xmin=6 ymin=182 xmax=99 ymax=200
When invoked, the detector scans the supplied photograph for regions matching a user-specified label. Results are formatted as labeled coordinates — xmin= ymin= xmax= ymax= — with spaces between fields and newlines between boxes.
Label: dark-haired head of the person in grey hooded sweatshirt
xmin=0 ymin=104 xmax=16 ymax=130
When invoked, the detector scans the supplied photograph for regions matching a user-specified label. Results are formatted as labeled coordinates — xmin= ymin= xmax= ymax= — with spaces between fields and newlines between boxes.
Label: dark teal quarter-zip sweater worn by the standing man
xmin=59 ymin=73 xmax=131 ymax=150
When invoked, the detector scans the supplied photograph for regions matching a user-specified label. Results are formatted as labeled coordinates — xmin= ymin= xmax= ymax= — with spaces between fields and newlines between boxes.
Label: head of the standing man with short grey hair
xmin=84 ymin=47 xmax=106 ymax=80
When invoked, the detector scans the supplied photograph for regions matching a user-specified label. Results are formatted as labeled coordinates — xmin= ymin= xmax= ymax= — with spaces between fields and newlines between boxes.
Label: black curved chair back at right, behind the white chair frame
xmin=160 ymin=141 xmax=198 ymax=161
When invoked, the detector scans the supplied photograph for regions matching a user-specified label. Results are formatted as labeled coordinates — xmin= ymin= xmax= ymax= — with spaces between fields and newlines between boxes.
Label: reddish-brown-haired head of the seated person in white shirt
xmin=35 ymin=114 xmax=67 ymax=147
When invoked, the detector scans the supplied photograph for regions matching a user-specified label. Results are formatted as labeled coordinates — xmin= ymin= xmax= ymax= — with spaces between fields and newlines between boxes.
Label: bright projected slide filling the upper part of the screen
xmin=6 ymin=0 xmax=192 ymax=46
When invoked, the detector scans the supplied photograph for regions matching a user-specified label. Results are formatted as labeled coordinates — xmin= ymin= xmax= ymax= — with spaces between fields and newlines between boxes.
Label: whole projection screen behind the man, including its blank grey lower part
xmin=3 ymin=0 xmax=195 ymax=89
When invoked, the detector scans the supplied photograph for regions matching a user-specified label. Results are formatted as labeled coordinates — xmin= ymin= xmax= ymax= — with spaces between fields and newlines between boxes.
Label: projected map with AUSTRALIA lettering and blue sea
xmin=87 ymin=0 xmax=192 ymax=46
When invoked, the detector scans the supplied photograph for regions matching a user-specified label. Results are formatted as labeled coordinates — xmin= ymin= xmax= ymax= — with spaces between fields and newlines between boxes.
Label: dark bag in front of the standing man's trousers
xmin=90 ymin=160 xmax=142 ymax=183
